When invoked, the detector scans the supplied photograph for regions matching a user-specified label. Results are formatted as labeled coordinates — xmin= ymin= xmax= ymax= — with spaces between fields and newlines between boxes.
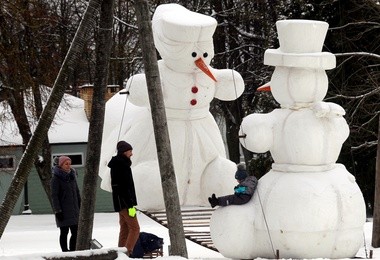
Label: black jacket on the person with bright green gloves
xmin=108 ymin=154 xmax=137 ymax=212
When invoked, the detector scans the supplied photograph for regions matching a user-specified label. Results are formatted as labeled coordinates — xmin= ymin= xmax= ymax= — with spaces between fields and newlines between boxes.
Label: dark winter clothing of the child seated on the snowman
xmin=218 ymin=176 xmax=257 ymax=206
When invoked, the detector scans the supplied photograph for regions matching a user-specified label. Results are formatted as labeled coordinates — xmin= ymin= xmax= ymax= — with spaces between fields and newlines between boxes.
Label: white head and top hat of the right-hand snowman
xmin=264 ymin=19 xmax=336 ymax=108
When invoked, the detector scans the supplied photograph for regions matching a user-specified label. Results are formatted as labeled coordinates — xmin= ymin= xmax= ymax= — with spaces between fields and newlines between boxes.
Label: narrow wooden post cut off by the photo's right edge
xmin=372 ymin=116 xmax=380 ymax=248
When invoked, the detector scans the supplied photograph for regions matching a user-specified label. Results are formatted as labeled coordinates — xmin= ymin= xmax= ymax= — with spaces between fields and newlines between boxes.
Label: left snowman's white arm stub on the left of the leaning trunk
xmin=125 ymin=74 xmax=149 ymax=107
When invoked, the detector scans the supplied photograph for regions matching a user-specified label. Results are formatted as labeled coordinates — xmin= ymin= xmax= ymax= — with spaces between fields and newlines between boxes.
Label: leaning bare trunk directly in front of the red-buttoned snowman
xmin=135 ymin=0 xmax=187 ymax=258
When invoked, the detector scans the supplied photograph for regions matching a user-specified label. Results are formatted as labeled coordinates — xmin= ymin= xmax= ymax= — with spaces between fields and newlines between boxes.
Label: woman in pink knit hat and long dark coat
xmin=51 ymin=156 xmax=81 ymax=252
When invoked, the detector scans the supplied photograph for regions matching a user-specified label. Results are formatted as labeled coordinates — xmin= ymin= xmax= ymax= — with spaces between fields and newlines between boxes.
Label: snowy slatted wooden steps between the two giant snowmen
xmin=143 ymin=207 xmax=218 ymax=252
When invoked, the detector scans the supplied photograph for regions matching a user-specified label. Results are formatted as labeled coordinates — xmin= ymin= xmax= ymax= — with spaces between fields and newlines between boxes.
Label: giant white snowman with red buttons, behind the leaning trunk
xmin=100 ymin=4 xmax=244 ymax=210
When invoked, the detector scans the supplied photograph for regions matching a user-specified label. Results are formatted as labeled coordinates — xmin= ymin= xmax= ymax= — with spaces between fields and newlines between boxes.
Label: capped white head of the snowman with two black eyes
xmin=152 ymin=4 xmax=217 ymax=73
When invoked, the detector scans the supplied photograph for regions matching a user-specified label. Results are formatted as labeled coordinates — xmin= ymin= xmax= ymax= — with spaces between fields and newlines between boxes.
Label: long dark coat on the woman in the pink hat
xmin=51 ymin=166 xmax=81 ymax=227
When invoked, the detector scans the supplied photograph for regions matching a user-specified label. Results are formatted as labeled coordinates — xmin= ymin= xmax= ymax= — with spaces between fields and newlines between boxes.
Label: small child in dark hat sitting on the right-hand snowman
xmin=208 ymin=164 xmax=257 ymax=208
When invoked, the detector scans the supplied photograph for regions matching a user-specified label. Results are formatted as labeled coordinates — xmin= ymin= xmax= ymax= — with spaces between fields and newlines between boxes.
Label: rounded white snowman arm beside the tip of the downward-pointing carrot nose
xmin=212 ymin=69 xmax=244 ymax=101
